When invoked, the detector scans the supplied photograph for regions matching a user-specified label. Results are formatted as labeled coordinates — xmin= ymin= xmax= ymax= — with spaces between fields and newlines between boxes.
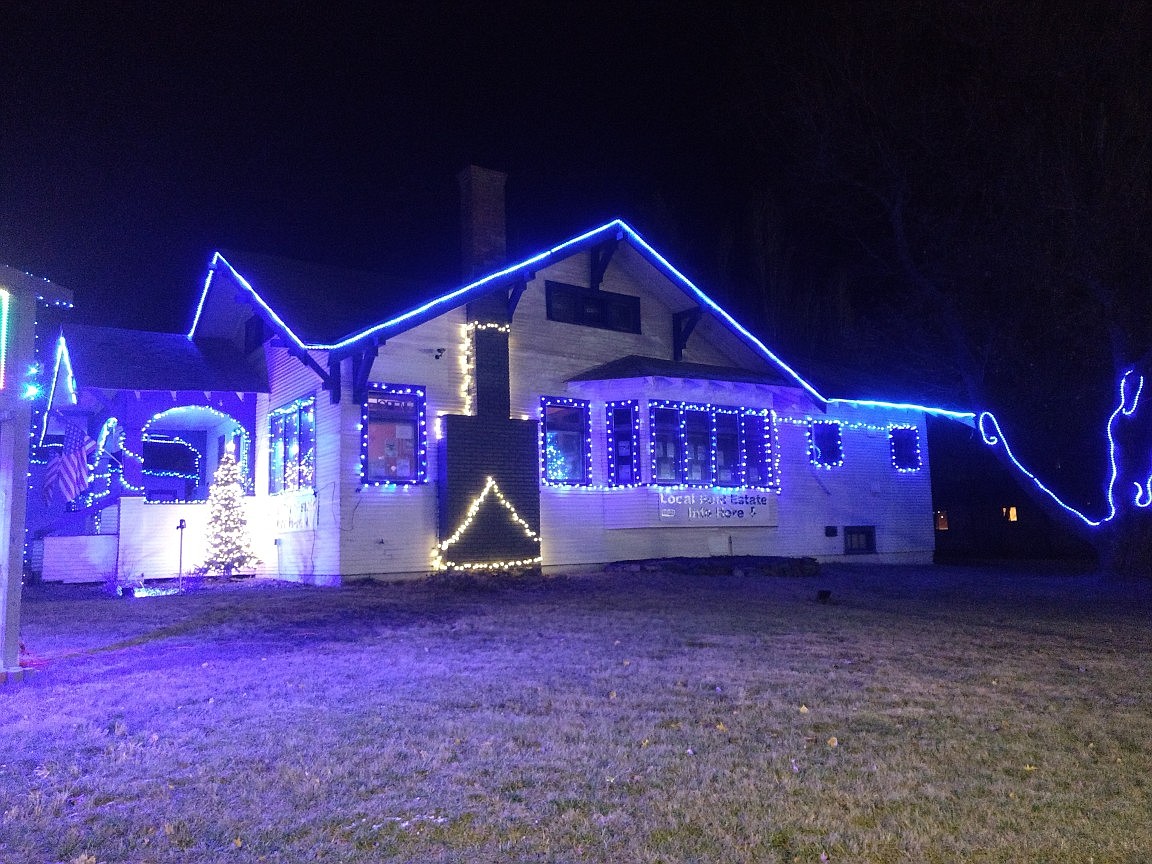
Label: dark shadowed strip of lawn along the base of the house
xmin=24 ymin=559 xmax=1152 ymax=677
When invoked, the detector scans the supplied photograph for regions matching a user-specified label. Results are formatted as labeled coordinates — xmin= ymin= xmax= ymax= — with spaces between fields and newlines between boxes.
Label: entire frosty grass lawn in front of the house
xmin=0 ymin=566 xmax=1152 ymax=864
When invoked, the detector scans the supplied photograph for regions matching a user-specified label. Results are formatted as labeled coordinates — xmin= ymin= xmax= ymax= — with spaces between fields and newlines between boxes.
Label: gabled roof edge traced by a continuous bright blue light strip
xmin=189 ymin=219 xmax=975 ymax=423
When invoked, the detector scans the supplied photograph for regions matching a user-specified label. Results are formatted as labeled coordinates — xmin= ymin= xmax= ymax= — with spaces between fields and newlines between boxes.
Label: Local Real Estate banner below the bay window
xmin=604 ymin=486 xmax=778 ymax=528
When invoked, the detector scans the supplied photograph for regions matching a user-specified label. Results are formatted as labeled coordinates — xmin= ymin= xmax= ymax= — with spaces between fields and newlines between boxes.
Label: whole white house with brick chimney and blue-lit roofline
xmin=29 ymin=167 xmax=971 ymax=583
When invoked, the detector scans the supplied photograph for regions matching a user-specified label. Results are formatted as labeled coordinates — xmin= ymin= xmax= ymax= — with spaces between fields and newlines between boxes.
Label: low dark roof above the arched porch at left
xmin=62 ymin=324 xmax=268 ymax=393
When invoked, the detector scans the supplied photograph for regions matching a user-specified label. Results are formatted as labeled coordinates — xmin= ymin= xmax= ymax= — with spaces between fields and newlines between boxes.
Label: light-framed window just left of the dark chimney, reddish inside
xmin=361 ymin=384 xmax=427 ymax=485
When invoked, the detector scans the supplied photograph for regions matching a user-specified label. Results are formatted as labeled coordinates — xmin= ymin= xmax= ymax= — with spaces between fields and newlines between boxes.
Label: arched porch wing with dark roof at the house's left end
xmin=26 ymin=323 xmax=268 ymax=582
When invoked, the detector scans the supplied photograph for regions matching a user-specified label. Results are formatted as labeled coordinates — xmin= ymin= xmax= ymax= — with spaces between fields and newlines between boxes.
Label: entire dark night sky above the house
xmin=0 ymin=0 xmax=1152 ymax=511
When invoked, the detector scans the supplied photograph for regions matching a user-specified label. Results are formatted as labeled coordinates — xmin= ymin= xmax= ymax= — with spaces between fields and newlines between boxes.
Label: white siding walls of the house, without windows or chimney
xmin=256 ymin=244 xmax=934 ymax=582
